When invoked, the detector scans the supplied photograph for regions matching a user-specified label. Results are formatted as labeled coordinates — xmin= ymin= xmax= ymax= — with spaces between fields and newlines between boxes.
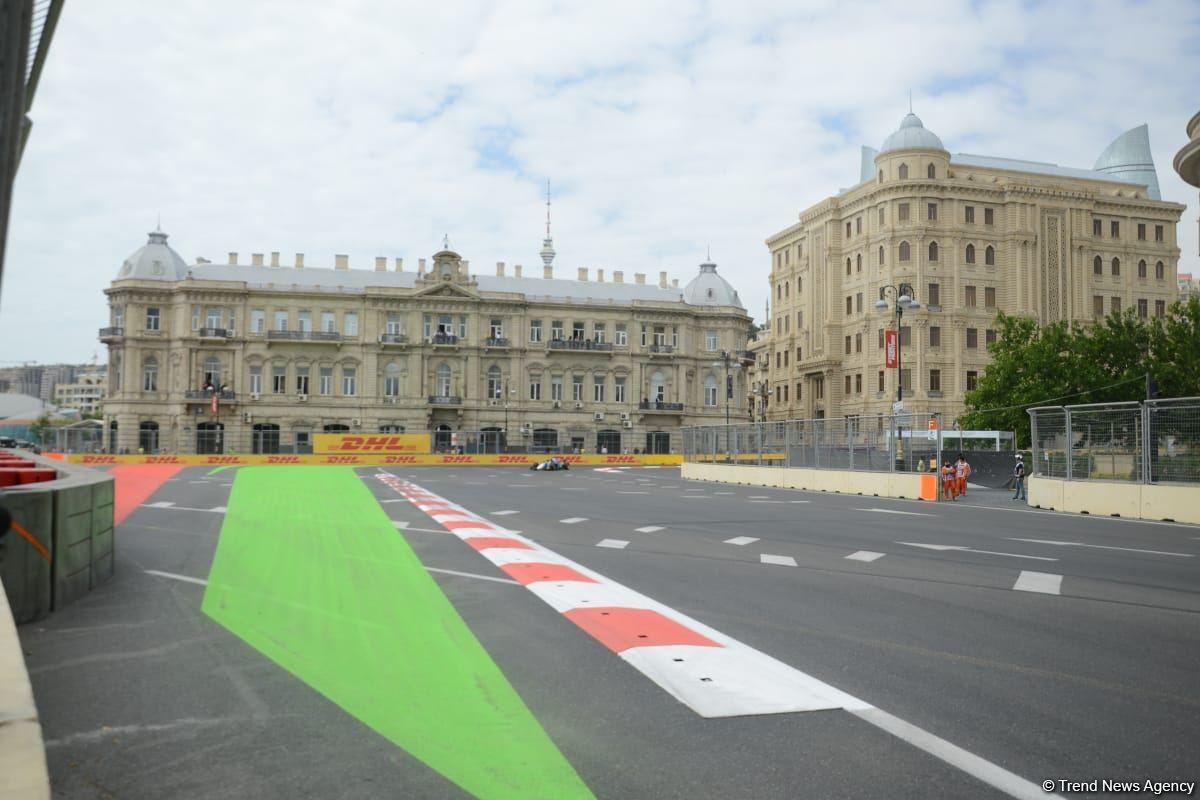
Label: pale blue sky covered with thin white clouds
xmin=0 ymin=0 xmax=1200 ymax=366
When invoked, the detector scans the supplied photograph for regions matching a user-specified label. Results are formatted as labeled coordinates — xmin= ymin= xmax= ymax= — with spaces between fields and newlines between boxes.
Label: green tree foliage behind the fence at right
xmin=959 ymin=297 xmax=1200 ymax=446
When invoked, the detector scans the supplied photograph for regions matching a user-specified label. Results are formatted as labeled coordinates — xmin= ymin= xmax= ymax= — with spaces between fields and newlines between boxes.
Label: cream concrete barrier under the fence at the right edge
xmin=1028 ymin=476 xmax=1200 ymax=524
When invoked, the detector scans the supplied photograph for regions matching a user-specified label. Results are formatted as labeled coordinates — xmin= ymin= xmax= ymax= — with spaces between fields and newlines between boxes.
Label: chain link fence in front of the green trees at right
xmin=1028 ymin=397 xmax=1200 ymax=483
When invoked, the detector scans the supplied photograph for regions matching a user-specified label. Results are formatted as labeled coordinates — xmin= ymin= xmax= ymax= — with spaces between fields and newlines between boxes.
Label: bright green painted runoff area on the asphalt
xmin=203 ymin=467 xmax=593 ymax=800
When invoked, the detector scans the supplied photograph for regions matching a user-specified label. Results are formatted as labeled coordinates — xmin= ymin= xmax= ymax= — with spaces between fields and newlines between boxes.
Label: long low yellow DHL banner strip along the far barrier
xmin=66 ymin=452 xmax=683 ymax=467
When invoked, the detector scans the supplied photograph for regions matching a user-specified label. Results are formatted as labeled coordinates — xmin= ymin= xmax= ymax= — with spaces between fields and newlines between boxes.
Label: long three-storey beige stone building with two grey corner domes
xmin=100 ymin=225 xmax=750 ymax=453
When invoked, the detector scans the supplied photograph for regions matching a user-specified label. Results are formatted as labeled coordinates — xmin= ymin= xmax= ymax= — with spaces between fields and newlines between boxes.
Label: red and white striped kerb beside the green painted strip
xmin=377 ymin=473 xmax=871 ymax=717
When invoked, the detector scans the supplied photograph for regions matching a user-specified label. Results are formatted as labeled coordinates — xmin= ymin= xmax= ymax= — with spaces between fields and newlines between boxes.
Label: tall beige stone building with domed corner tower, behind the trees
xmin=767 ymin=113 xmax=1184 ymax=420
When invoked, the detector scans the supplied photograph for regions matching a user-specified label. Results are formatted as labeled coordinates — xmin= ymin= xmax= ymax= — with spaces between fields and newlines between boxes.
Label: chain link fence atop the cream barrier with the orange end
xmin=682 ymin=413 xmax=942 ymax=473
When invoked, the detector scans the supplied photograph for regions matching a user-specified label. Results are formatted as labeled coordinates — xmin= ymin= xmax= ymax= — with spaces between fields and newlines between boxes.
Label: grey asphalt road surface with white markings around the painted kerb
xmin=22 ymin=468 xmax=1200 ymax=799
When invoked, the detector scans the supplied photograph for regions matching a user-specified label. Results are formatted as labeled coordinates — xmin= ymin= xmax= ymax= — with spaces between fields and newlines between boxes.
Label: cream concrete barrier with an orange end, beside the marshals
xmin=683 ymin=462 xmax=937 ymax=500
